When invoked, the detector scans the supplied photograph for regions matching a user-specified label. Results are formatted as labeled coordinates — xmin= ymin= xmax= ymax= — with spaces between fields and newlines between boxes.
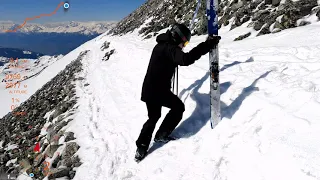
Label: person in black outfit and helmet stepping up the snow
xmin=135 ymin=24 xmax=221 ymax=160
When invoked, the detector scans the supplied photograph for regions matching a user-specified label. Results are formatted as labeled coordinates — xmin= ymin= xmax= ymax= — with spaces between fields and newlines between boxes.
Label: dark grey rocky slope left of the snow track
xmin=0 ymin=51 xmax=87 ymax=179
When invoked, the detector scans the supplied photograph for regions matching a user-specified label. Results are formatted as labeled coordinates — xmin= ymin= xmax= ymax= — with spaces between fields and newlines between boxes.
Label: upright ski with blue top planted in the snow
xmin=207 ymin=0 xmax=221 ymax=129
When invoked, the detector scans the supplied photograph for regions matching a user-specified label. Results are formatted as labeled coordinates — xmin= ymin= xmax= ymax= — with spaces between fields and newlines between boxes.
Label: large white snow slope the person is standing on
xmin=1 ymin=16 xmax=320 ymax=180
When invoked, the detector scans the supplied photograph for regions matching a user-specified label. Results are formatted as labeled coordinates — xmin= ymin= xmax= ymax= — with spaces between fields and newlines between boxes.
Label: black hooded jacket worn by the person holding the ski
xmin=141 ymin=32 xmax=210 ymax=102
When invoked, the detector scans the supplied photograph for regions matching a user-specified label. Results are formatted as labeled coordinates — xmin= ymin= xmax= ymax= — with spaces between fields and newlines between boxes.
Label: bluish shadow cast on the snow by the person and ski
xmin=149 ymin=61 xmax=271 ymax=154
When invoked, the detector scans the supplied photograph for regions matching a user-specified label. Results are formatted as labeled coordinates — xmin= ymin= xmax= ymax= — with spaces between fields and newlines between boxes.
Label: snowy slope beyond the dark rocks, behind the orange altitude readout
xmin=0 ymin=55 xmax=63 ymax=117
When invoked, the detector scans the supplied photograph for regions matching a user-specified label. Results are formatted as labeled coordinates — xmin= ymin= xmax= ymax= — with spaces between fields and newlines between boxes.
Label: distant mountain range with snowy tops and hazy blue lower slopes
xmin=0 ymin=21 xmax=116 ymax=56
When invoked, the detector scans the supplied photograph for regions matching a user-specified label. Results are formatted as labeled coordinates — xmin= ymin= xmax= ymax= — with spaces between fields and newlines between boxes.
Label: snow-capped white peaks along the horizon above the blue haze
xmin=0 ymin=21 xmax=116 ymax=35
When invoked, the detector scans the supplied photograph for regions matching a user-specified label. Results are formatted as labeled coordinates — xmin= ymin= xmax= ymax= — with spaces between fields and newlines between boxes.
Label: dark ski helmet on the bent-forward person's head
xmin=170 ymin=23 xmax=191 ymax=47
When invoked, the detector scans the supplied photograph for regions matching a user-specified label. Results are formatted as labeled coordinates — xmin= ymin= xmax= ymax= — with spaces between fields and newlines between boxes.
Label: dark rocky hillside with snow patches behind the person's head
xmin=110 ymin=0 xmax=320 ymax=40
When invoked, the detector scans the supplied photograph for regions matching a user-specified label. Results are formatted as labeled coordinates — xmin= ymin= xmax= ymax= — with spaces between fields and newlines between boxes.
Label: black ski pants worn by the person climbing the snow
xmin=136 ymin=92 xmax=185 ymax=148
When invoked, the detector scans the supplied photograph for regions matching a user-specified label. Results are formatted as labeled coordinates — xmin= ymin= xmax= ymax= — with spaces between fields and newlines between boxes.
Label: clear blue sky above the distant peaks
xmin=0 ymin=0 xmax=146 ymax=23
